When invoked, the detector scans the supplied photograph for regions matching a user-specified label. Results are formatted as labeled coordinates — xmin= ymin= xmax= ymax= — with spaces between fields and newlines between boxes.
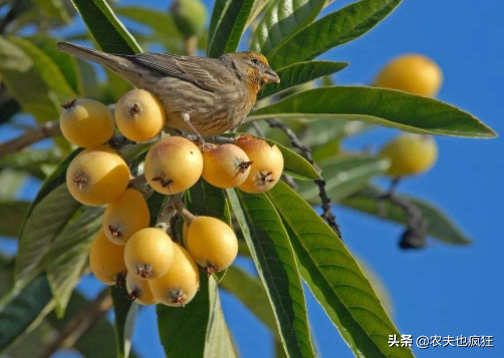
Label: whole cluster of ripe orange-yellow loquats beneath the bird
xmin=60 ymin=89 xmax=284 ymax=306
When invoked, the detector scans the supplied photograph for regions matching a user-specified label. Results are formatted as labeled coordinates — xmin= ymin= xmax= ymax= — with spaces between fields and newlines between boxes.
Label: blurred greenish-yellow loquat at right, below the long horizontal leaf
xmin=380 ymin=134 xmax=438 ymax=177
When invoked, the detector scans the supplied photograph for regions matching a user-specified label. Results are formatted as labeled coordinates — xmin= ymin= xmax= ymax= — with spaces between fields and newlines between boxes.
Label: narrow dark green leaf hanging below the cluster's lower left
xmin=110 ymin=286 xmax=138 ymax=358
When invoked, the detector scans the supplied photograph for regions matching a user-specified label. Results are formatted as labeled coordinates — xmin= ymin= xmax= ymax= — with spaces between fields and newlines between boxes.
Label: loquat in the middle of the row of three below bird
xmin=202 ymin=144 xmax=252 ymax=189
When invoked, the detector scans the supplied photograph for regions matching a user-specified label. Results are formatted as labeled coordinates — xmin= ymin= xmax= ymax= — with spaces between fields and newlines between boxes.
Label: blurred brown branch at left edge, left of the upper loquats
xmin=0 ymin=121 xmax=61 ymax=158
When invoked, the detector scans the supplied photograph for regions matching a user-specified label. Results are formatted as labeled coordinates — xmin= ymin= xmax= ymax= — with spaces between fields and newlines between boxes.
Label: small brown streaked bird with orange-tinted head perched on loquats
xmin=58 ymin=42 xmax=280 ymax=136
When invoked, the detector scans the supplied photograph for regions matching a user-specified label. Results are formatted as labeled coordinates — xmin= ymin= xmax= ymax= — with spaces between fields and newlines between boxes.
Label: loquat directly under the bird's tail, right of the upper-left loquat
xmin=115 ymin=89 xmax=166 ymax=142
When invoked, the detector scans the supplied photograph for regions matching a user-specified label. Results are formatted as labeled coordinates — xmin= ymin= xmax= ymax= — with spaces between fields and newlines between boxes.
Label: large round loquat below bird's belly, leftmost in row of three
xmin=144 ymin=137 xmax=203 ymax=195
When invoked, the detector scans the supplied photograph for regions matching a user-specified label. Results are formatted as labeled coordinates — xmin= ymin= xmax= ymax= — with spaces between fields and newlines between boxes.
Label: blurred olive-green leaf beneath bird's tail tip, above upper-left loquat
xmin=30 ymin=34 xmax=83 ymax=94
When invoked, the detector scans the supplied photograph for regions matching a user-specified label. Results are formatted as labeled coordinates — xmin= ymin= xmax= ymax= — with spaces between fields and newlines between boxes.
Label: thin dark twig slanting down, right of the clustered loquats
xmin=267 ymin=119 xmax=342 ymax=238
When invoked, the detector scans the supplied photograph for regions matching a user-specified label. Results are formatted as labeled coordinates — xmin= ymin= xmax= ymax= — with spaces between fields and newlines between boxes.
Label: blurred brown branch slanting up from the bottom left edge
xmin=39 ymin=288 xmax=113 ymax=358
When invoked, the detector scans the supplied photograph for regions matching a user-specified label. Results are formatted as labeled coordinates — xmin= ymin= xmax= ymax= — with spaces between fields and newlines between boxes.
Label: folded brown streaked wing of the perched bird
xmin=124 ymin=53 xmax=227 ymax=92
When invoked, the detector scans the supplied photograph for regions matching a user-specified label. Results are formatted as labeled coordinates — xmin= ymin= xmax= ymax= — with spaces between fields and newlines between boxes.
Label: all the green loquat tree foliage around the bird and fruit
xmin=0 ymin=0 xmax=496 ymax=357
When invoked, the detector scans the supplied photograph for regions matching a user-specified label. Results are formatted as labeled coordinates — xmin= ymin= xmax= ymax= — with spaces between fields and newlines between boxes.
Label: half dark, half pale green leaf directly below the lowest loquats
xmin=157 ymin=274 xmax=236 ymax=358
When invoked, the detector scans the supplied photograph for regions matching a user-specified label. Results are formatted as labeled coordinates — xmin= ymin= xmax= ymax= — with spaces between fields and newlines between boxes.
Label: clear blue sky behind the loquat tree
xmin=1 ymin=0 xmax=504 ymax=357
